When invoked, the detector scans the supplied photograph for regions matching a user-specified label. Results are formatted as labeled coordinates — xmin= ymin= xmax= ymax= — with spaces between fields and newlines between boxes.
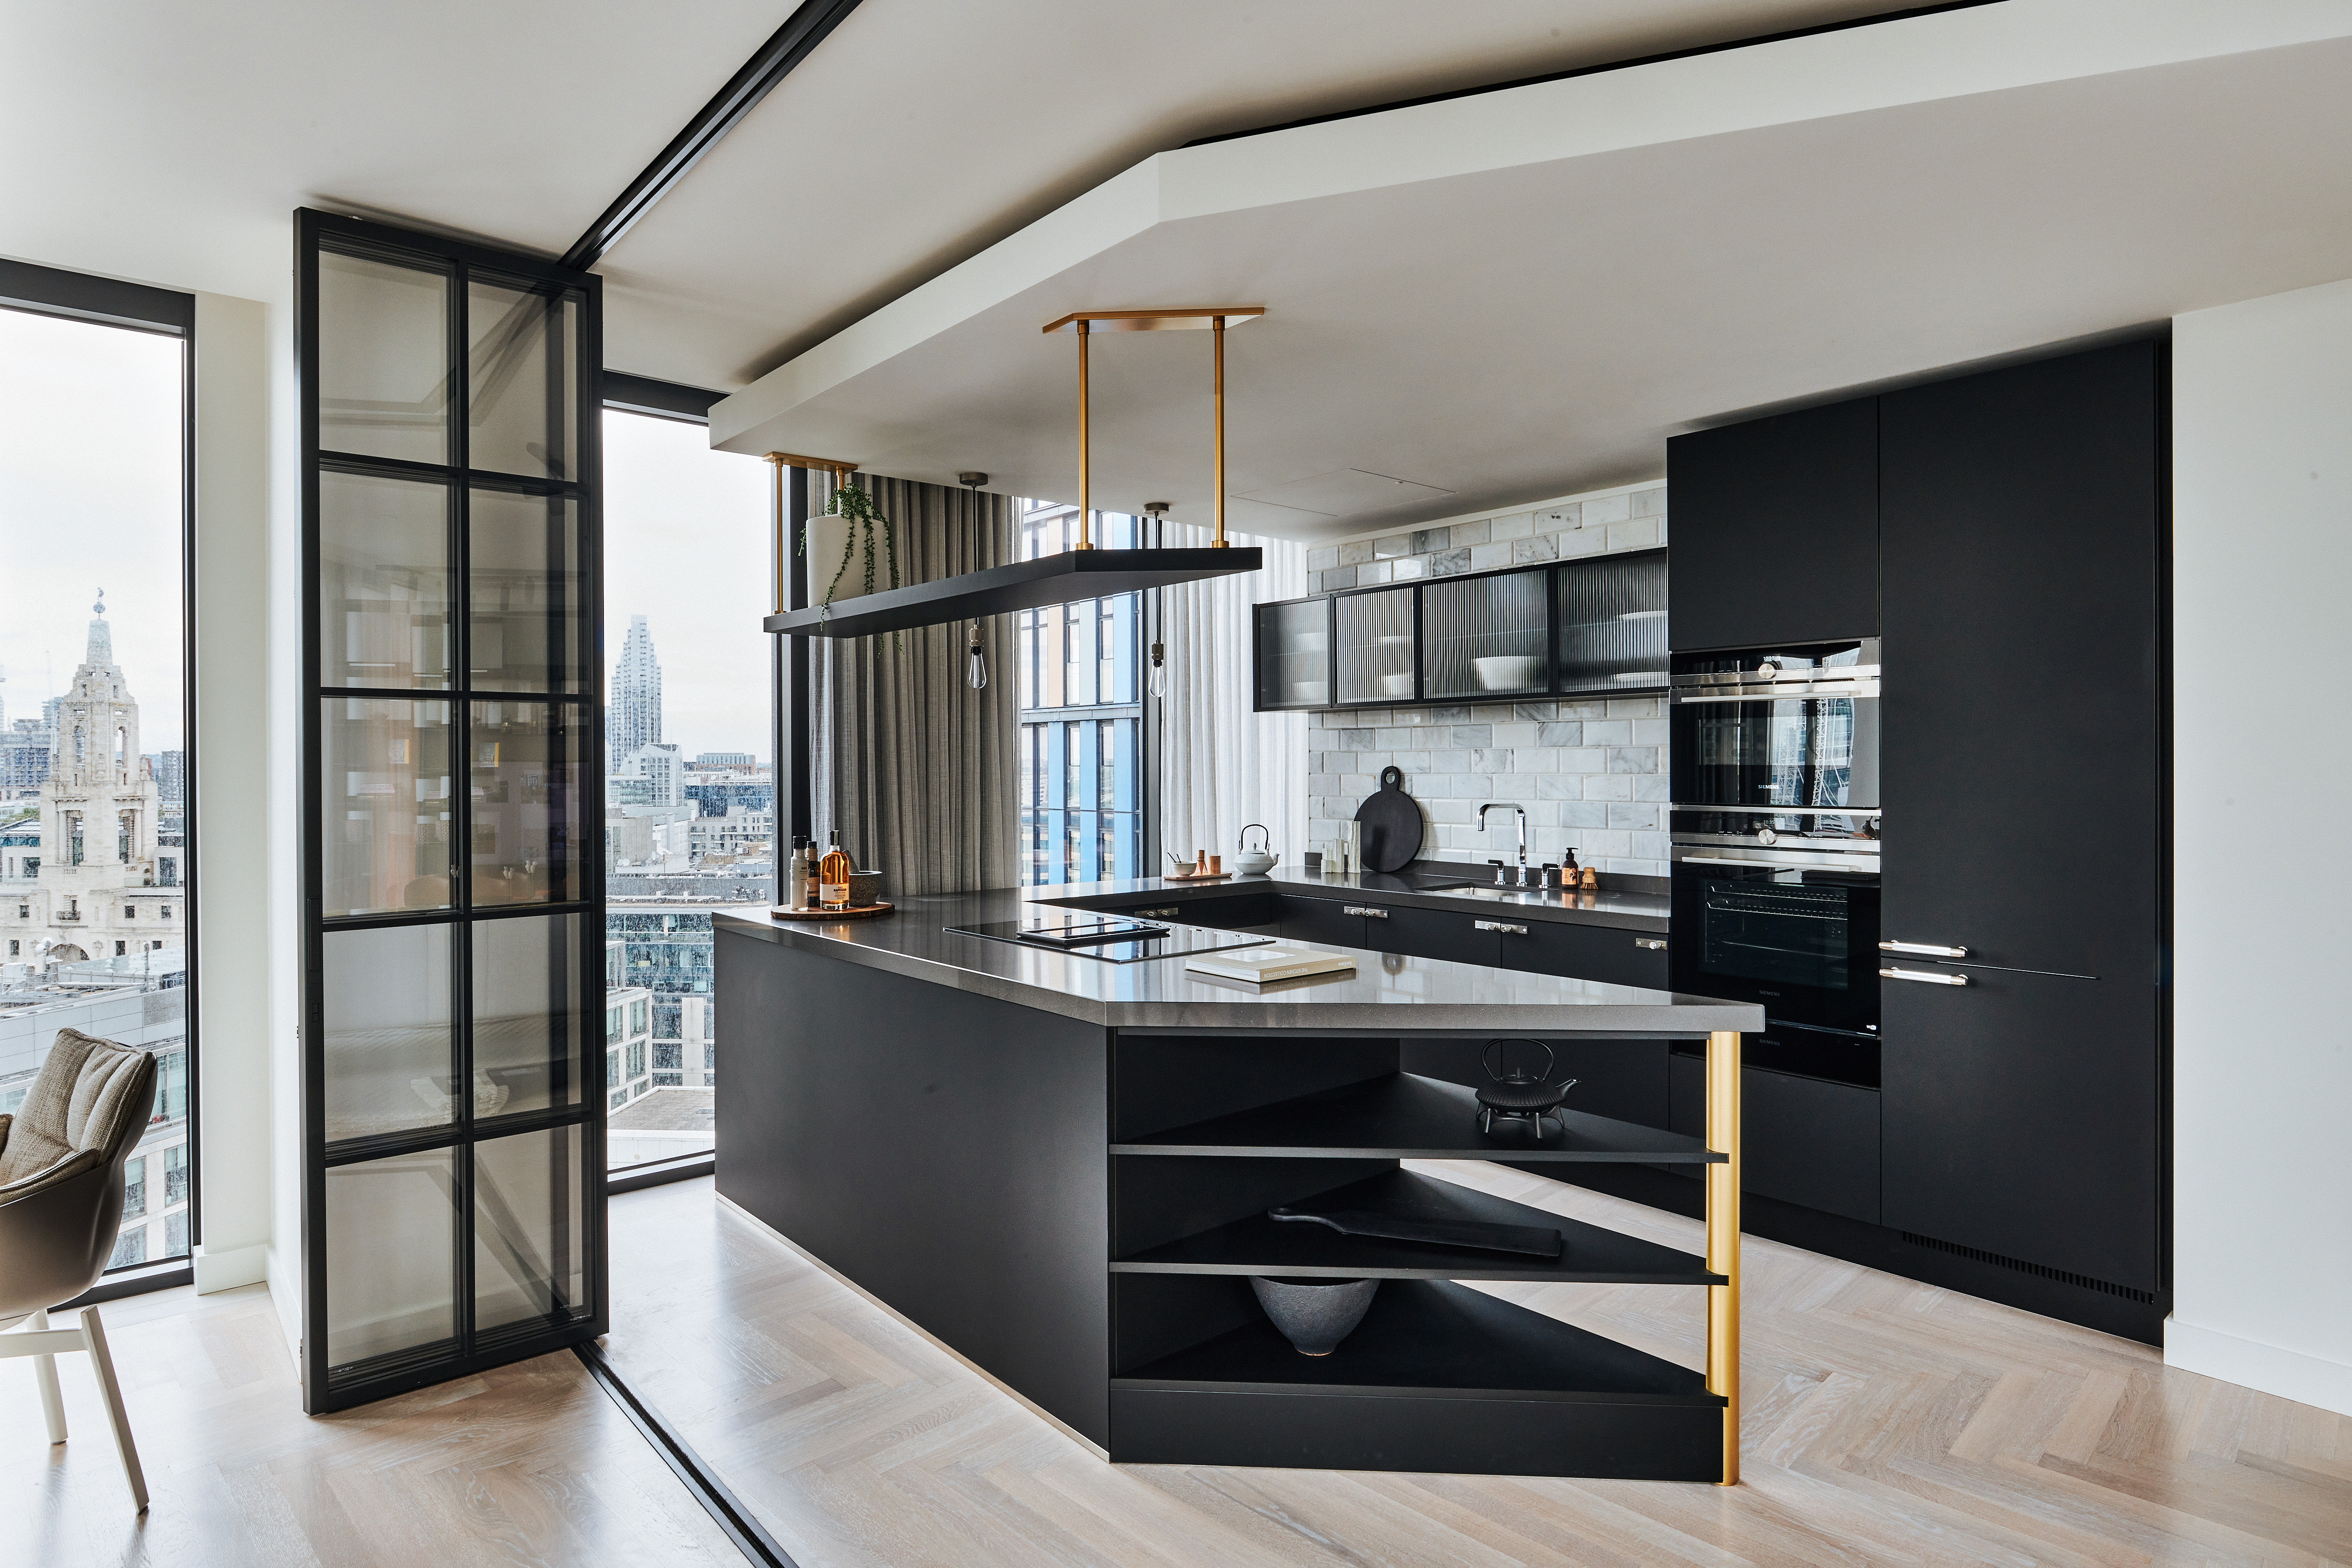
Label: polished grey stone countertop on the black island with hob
xmin=712 ymin=882 xmax=1764 ymax=1039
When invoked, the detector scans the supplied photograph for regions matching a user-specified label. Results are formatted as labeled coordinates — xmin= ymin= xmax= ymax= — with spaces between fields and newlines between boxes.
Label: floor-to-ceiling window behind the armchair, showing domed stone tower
xmin=0 ymin=263 xmax=198 ymax=1269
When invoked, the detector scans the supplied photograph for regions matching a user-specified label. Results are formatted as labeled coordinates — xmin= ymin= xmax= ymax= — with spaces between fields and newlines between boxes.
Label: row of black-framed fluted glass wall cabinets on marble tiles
xmin=1256 ymin=550 xmax=1667 ymax=712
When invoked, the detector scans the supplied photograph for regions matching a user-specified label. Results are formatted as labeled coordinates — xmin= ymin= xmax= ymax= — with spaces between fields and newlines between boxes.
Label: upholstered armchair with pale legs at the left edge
xmin=0 ymin=1030 xmax=155 ymax=1512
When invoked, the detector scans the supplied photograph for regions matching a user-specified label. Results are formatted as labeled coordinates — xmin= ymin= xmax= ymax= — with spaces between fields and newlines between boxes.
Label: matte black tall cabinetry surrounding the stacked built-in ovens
xmin=1667 ymin=341 xmax=2171 ymax=1340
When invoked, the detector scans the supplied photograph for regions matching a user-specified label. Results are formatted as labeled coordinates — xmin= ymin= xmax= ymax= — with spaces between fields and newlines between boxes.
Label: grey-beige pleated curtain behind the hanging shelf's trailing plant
xmin=809 ymin=472 xmax=1018 ymax=900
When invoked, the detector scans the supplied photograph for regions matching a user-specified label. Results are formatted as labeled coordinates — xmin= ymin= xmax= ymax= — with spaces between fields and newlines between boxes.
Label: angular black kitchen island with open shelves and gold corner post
xmin=715 ymin=884 xmax=1762 ymax=1481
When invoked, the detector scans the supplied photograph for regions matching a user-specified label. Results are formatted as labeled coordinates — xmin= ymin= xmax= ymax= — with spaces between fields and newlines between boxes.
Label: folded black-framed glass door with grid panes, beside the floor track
xmin=294 ymin=209 xmax=607 ymax=1413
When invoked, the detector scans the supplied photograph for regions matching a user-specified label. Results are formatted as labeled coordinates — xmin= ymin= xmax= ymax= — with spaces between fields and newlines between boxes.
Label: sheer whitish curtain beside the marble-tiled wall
xmin=1160 ymin=524 xmax=1310 ymax=865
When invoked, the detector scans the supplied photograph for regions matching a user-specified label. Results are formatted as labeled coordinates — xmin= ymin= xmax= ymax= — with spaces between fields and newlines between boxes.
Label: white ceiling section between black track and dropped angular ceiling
xmin=588 ymin=0 xmax=1893 ymax=390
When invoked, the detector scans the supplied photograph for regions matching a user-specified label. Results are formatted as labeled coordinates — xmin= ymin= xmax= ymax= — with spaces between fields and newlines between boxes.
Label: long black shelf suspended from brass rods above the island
xmin=760 ymin=548 xmax=1266 ymax=637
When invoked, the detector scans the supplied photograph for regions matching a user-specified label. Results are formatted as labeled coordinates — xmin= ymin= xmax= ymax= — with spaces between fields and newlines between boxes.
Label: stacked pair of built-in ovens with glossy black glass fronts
xmin=1667 ymin=637 xmax=1884 ymax=1037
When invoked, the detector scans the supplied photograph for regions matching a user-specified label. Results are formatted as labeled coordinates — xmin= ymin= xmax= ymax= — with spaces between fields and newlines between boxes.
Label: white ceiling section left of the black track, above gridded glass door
xmin=0 ymin=0 xmax=790 ymax=299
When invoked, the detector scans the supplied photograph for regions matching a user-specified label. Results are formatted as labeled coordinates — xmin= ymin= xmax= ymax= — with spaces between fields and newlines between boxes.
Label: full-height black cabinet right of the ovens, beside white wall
xmin=1872 ymin=343 xmax=2166 ymax=1291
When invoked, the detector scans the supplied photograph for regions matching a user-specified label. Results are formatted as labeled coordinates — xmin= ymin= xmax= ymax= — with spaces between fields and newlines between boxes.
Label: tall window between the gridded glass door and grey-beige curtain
xmin=604 ymin=407 xmax=776 ymax=1171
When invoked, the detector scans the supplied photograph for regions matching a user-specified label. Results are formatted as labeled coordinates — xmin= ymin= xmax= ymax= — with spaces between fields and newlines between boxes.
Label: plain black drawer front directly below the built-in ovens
xmin=1667 ymin=1055 xmax=1879 ymax=1225
